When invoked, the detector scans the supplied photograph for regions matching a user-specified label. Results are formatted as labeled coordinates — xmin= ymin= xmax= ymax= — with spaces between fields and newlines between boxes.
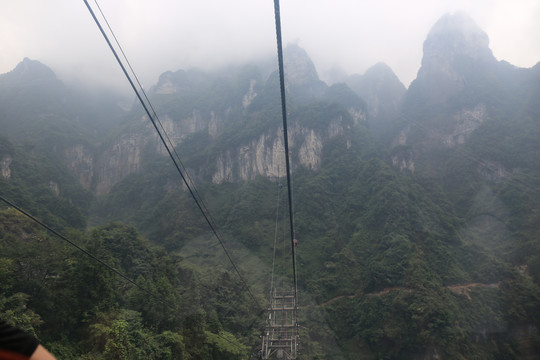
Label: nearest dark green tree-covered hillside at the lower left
xmin=0 ymin=209 xmax=255 ymax=359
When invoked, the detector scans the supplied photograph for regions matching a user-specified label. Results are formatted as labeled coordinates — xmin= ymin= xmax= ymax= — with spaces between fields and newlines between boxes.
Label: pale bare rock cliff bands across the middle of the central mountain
xmin=64 ymin=101 xmax=365 ymax=195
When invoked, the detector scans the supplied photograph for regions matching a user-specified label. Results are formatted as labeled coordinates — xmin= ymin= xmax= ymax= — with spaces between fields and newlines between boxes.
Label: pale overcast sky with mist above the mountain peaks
xmin=0 ymin=0 xmax=540 ymax=93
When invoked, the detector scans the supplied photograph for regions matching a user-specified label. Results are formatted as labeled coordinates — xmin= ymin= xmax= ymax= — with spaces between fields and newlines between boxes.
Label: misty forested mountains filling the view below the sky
xmin=0 ymin=14 xmax=540 ymax=359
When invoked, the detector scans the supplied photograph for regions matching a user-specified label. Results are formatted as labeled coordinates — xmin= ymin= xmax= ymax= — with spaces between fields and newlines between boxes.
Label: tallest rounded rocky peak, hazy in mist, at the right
xmin=391 ymin=13 xmax=525 ymax=170
